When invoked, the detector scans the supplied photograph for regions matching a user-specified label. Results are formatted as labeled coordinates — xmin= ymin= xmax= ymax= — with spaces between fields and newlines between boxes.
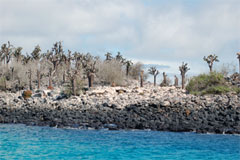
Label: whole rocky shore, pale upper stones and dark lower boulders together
xmin=0 ymin=85 xmax=240 ymax=134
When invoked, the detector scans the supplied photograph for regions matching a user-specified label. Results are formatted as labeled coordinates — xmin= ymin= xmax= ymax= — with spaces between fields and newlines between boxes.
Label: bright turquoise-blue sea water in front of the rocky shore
xmin=0 ymin=124 xmax=240 ymax=160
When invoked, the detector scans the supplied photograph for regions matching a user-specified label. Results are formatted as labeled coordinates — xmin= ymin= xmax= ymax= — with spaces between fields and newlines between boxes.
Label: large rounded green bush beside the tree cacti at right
xmin=186 ymin=72 xmax=232 ymax=95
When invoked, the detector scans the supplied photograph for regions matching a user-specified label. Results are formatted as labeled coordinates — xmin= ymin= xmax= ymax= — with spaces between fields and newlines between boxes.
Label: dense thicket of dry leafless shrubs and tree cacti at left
xmin=0 ymin=42 xmax=143 ymax=95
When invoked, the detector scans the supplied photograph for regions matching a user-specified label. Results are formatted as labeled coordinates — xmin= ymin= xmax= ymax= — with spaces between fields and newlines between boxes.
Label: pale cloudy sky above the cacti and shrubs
xmin=0 ymin=0 xmax=240 ymax=73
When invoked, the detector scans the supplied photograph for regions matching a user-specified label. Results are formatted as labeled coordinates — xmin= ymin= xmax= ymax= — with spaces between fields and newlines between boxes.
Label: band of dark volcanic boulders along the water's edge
xmin=0 ymin=91 xmax=240 ymax=134
